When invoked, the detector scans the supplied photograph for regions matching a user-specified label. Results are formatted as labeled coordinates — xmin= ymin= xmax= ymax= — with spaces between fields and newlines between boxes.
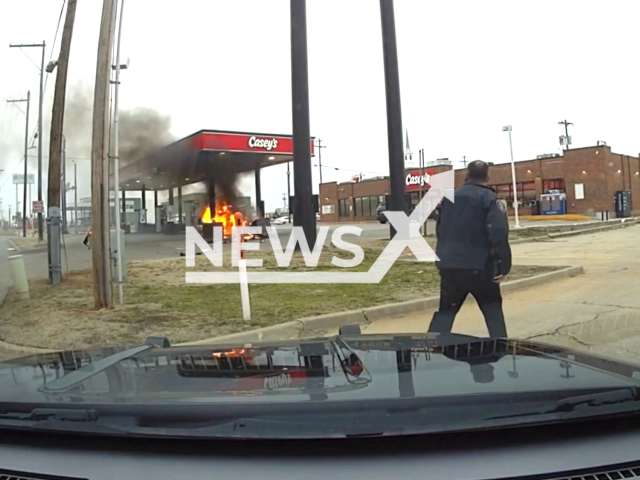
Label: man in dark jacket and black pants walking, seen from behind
xmin=429 ymin=160 xmax=511 ymax=338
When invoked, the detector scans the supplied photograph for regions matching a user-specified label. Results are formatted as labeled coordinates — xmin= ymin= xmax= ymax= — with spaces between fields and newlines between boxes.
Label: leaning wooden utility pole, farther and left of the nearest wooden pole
xmin=47 ymin=0 xmax=77 ymax=212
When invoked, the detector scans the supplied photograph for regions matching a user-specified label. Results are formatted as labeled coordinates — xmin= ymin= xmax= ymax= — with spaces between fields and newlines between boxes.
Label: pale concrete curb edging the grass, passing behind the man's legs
xmin=179 ymin=266 xmax=584 ymax=345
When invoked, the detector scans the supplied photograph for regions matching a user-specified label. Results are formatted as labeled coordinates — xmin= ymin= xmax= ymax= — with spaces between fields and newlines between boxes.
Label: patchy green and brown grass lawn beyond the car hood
xmin=0 ymin=241 xmax=553 ymax=348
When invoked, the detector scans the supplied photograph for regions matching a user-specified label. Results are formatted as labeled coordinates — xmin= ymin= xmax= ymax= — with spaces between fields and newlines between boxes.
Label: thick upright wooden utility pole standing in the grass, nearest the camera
xmin=91 ymin=0 xmax=115 ymax=308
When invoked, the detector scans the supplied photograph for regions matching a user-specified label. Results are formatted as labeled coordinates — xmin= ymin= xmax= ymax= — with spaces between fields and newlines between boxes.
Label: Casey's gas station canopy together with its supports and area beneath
xmin=119 ymin=130 xmax=314 ymax=234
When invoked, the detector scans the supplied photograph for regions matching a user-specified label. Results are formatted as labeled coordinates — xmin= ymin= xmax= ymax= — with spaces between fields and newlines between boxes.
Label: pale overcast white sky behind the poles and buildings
xmin=0 ymin=0 xmax=640 ymax=215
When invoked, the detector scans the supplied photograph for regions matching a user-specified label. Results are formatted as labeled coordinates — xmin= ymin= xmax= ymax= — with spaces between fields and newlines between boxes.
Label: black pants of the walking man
xmin=429 ymin=269 xmax=507 ymax=338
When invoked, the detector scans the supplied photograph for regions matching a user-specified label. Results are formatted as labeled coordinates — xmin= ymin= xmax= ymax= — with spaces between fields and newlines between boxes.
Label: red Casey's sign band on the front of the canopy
xmin=193 ymin=132 xmax=314 ymax=155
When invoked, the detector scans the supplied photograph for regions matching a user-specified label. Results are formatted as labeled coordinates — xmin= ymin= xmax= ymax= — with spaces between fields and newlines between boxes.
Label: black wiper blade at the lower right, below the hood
xmin=487 ymin=388 xmax=640 ymax=420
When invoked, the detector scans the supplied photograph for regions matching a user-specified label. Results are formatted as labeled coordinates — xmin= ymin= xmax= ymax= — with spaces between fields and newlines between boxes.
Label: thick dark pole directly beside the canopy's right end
xmin=289 ymin=0 xmax=317 ymax=248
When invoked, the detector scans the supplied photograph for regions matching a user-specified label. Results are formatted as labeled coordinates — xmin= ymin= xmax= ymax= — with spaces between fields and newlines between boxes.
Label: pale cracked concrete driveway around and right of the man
xmin=350 ymin=226 xmax=640 ymax=361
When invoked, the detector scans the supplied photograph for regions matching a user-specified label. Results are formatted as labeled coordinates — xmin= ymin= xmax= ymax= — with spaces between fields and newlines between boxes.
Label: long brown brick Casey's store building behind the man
xmin=319 ymin=145 xmax=640 ymax=222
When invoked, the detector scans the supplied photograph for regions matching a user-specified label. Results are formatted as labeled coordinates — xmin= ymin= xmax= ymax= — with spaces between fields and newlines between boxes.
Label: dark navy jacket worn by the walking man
xmin=436 ymin=182 xmax=511 ymax=276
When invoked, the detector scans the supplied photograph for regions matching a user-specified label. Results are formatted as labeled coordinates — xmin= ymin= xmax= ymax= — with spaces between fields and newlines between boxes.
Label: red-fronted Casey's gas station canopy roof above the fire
xmin=119 ymin=130 xmax=314 ymax=190
